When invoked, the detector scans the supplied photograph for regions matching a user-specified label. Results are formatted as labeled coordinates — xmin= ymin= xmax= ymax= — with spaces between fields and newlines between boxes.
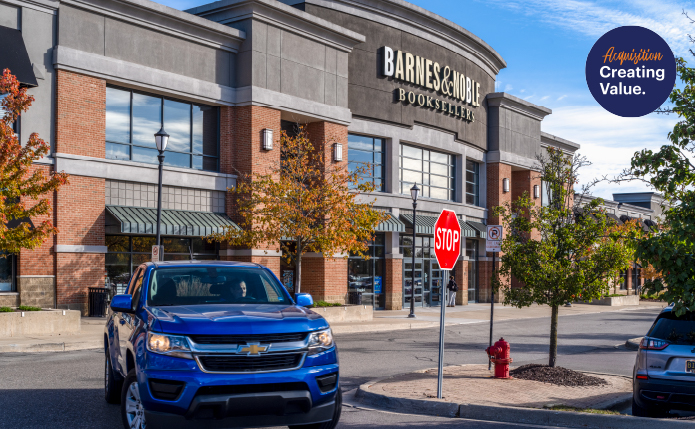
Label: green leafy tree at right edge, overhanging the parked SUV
xmin=619 ymin=58 xmax=695 ymax=315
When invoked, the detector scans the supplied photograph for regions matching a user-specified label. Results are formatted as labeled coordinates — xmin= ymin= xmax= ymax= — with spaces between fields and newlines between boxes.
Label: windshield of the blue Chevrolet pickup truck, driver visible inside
xmin=147 ymin=267 xmax=290 ymax=306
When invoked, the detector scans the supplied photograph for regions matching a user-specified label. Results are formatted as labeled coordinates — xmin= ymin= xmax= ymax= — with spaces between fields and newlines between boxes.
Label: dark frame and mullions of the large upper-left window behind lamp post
xmin=104 ymin=85 xmax=221 ymax=173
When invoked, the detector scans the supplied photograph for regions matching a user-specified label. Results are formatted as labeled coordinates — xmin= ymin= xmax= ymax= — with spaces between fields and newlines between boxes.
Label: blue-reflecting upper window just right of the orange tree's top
xmin=348 ymin=134 xmax=385 ymax=191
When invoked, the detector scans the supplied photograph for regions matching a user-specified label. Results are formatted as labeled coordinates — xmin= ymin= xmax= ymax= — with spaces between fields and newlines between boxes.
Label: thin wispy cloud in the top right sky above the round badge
xmin=491 ymin=0 xmax=695 ymax=56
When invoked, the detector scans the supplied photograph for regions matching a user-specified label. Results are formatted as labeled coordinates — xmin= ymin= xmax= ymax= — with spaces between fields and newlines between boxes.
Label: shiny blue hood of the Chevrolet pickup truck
xmin=148 ymin=304 xmax=328 ymax=335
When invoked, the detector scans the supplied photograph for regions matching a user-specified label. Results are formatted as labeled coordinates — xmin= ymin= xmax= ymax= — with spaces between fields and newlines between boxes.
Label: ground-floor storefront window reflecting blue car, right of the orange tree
xmin=348 ymin=233 xmax=386 ymax=308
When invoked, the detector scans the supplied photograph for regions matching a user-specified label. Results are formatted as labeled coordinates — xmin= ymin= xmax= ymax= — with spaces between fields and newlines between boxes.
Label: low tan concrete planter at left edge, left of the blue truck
xmin=0 ymin=310 xmax=80 ymax=338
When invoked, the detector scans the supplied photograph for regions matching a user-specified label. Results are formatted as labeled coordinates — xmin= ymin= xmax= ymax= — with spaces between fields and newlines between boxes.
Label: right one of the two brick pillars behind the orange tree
xmin=301 ymin=122 xmax=348 ymax=303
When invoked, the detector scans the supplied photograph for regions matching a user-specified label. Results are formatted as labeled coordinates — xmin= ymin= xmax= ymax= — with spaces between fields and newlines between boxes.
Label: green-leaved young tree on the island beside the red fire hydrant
xmin=493 ymin=147 xmax=636 ymax=367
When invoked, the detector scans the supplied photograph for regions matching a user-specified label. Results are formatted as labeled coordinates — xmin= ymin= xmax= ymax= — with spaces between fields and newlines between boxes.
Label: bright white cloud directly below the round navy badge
xmin=542 ymin=106 xmax=677 ymax=199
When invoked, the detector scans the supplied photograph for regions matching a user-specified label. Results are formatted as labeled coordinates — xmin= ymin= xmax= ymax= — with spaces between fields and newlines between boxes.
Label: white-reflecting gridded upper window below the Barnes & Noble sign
xmin=400 ymin=145 xmax=456 ymax=201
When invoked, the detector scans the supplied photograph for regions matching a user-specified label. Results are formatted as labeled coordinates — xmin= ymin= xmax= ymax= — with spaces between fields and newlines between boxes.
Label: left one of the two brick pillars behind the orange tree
xmin=220 ymin=106 xmax=280 ymax=277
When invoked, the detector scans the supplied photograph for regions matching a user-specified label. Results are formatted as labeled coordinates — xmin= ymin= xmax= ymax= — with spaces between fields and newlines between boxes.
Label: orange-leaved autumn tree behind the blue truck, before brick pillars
xmin=208 ymin=127 xmax=388 ymax=293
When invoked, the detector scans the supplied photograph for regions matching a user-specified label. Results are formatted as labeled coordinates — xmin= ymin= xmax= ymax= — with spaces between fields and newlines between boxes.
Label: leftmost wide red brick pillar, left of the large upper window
xmin=55 ymin=70 xmax=106 ymax=314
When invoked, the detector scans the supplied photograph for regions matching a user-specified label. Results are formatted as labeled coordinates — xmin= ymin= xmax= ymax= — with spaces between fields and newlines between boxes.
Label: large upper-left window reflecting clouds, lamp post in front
xmin=106 ymin=87 xmax=219 ymax=171
